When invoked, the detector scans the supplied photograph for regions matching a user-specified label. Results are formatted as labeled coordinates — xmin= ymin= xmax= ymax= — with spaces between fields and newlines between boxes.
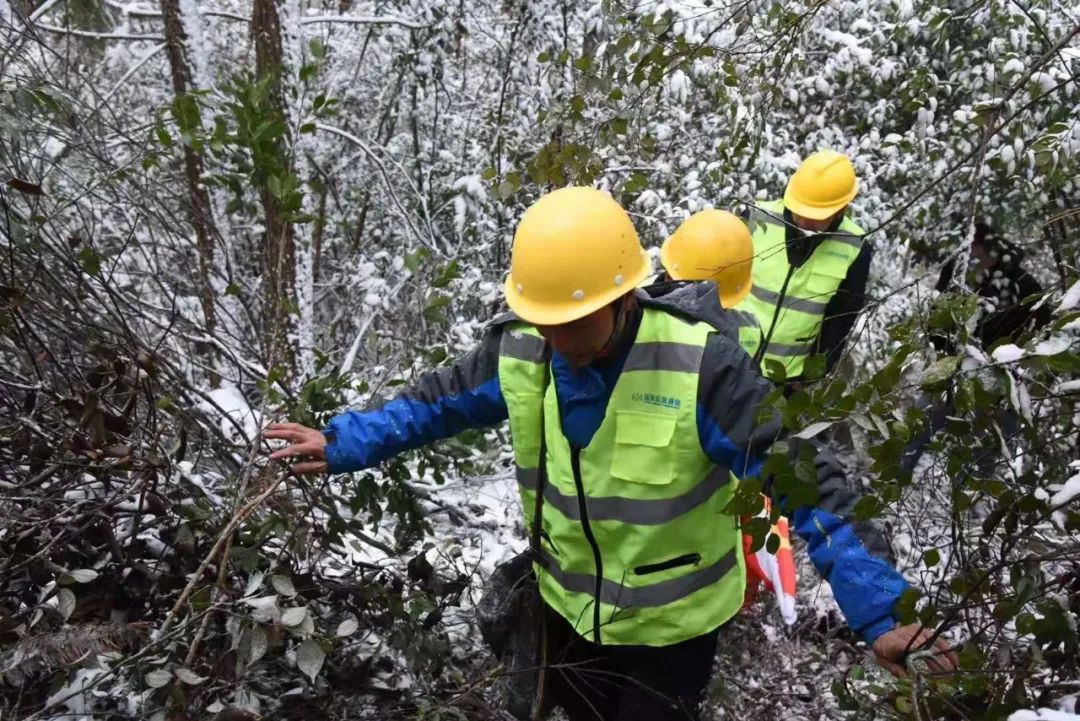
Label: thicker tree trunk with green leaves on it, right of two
xmin=252 ymin=0 xmax=296 ymax=376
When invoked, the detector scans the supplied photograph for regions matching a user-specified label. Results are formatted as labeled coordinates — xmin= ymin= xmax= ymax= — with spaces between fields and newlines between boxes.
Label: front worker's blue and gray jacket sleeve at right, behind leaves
xmin=698 ymin=334 xmax=907 ymax=643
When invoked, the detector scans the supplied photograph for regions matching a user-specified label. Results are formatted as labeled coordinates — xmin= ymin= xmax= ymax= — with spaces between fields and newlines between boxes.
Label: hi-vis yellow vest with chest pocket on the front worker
xmin=499 ymin=308 xmax=746 ymax=645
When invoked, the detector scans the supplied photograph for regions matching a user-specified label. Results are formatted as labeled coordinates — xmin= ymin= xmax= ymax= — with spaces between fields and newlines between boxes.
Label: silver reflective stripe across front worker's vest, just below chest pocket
xmin=515 ymin=466 xmax=731 ymax=526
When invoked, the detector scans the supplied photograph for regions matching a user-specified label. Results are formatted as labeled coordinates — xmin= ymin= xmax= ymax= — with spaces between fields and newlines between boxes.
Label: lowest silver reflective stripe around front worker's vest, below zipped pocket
xmin=540 ymin=547 xmax=738 ymax=609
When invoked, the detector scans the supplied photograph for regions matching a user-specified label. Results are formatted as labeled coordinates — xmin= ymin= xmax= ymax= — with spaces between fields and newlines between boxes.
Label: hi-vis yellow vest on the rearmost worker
xmin=739 ymin=201 xmax=863 ymax=378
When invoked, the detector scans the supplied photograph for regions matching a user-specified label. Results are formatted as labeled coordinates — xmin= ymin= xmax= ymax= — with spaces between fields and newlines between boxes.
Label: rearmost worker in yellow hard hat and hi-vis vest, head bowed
xmin=740 ymin=150 xmax=873 ymax=381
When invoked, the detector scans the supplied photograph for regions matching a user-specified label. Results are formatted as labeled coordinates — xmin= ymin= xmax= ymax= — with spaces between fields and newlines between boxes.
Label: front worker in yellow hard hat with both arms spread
xmin=264 ymin=188 xmax=954 ymax=721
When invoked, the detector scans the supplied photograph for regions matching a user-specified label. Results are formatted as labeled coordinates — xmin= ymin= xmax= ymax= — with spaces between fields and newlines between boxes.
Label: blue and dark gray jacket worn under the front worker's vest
xmin=324 ymin=283 xmax=907 ymax=643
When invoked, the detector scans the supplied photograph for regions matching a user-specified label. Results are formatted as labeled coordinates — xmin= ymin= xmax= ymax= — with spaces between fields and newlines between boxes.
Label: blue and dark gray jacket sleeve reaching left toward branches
xmin=323 ymin=325 xmax=507 ymax=473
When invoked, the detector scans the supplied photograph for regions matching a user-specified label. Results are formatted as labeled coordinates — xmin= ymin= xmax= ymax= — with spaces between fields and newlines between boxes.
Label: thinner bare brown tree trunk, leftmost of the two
xmin=161 ymin=0 xmax=219 ymax=387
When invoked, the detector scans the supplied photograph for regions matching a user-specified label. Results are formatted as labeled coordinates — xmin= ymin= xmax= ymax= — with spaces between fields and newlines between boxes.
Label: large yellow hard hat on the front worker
xmin=503 ymin=187 xmax=649 ymax=326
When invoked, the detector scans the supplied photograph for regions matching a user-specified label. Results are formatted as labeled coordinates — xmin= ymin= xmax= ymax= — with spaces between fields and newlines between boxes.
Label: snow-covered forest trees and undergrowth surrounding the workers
xmin=0 ymin=0 xmax=1080 ymax=721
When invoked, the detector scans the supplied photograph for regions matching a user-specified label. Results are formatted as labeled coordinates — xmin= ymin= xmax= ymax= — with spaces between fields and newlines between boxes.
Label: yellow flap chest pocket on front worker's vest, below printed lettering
xmin=610 ymin=410 xmax=677 ymax=486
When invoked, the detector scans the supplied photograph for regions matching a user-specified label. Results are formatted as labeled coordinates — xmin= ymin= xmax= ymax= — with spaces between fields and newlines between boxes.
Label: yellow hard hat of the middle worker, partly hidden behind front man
xmin=660 ymin=209 xmax=754 ymax=308
